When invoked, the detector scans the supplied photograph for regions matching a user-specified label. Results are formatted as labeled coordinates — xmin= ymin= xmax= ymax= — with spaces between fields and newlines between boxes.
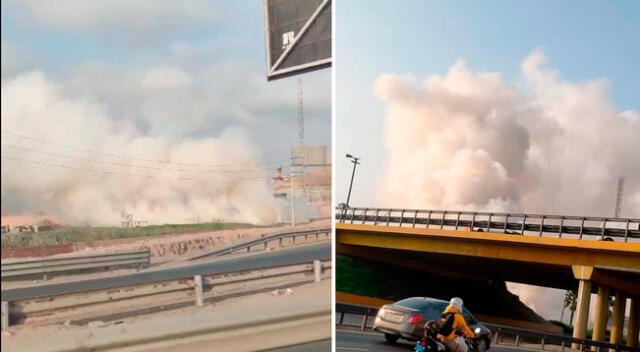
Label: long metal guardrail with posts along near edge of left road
xmin=2 ymin=260 xmax=331 ymax=330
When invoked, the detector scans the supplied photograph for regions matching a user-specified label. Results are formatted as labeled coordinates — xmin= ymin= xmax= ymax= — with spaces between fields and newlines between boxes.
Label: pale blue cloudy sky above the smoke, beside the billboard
xmin=2 ymin=0 xmax=331 ymax=159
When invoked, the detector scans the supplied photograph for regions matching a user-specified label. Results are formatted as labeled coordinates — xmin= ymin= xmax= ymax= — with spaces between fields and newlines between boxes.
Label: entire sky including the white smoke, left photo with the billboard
xmin=2 ymin=0 xmax=331 ymax=223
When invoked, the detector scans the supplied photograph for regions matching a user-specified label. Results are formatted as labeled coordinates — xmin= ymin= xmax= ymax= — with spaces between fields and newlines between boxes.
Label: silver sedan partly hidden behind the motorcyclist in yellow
xmin=373 ymin=297 xmax=491 ymax=351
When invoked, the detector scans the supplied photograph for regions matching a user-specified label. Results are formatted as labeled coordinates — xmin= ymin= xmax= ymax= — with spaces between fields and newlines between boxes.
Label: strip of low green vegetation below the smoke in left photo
xmin=2 ymin=222 xmax=258 ymax=247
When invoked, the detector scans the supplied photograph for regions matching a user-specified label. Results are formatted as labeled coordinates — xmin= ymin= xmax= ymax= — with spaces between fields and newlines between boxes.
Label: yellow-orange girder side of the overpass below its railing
xmin=336 ymin=223 xmax=640 ymax=271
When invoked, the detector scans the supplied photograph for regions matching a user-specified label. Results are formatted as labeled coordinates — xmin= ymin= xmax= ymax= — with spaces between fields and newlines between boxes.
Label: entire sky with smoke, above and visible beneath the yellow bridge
xmin=334 ymin=0 xmax=640 ymax=321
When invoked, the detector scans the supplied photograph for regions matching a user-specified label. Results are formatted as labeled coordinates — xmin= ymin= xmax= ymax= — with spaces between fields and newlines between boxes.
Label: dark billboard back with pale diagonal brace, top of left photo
xmin=263 ymin=0 xmax=331 ymax=80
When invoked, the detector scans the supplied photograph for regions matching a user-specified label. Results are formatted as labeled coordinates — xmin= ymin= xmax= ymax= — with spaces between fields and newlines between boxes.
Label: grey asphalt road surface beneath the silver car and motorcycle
xmin=335 ymin=329 xmax=532 ymax=352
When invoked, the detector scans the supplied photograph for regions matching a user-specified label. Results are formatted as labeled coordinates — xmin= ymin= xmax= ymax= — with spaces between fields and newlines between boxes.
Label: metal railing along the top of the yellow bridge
xmin=336 ymin=207 xmax=640 ymax=242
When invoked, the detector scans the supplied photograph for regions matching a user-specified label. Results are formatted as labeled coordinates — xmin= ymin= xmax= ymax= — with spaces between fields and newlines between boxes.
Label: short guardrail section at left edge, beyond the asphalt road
xmin=2 ymin=250 xmax=150 ymax=280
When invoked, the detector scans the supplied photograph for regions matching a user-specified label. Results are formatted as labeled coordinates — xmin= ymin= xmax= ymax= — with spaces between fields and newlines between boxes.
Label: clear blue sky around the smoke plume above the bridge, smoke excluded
xmin=335 ymin=0 xmax=640 ymax=207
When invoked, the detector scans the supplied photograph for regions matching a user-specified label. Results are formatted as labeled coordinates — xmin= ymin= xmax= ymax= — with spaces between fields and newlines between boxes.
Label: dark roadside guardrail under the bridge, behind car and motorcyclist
xmin=336 ymin=302 xmax=640 ymax=352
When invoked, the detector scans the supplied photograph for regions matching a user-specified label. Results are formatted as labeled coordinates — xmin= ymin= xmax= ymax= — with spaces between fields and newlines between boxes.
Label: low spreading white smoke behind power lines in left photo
xmin=2 ymin=72 xmax=280 ymax=224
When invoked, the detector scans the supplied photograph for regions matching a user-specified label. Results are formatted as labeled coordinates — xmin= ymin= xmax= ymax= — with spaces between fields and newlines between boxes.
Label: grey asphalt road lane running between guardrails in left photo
xmin=2 ymin=243 xmax=331 ymax=301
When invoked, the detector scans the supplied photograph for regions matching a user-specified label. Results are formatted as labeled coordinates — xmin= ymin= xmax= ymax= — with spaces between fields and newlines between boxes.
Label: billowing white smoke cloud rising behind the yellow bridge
xmin=374 ymin=50 xmax=640 ymax=216
